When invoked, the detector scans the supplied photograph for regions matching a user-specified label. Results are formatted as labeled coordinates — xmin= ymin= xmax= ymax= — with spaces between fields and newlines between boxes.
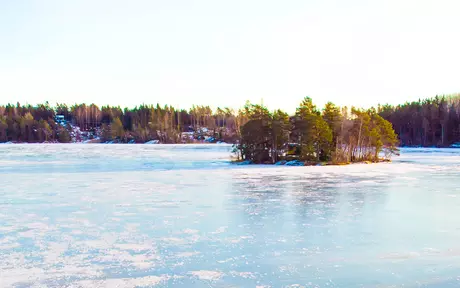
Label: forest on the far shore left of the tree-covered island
xmin=0 ymin=103 xmax=242 ymax=143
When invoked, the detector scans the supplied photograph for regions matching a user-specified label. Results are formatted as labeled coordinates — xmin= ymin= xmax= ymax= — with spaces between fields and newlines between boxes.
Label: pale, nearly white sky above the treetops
xmin=0 ymin=0 xmax=460 ymax=112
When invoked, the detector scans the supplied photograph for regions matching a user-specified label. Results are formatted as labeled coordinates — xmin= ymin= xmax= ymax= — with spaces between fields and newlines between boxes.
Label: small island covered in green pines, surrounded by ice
xmin=234 ymin=97 xmax=398 ymax=166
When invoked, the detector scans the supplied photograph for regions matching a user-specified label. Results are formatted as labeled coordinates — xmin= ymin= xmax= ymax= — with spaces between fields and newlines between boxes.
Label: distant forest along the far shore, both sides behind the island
xmin=0 ymin=95 xmax=460 ymax=147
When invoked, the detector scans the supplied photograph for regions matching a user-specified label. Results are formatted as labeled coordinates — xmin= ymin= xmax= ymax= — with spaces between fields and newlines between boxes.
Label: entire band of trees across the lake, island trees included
xmin=0 ymin=95 xmax=460 ymax=156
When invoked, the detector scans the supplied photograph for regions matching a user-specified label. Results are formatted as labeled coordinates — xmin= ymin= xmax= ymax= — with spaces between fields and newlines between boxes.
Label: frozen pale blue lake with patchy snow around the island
xmin=0 ymin=144 xmax=460 ymax=288
